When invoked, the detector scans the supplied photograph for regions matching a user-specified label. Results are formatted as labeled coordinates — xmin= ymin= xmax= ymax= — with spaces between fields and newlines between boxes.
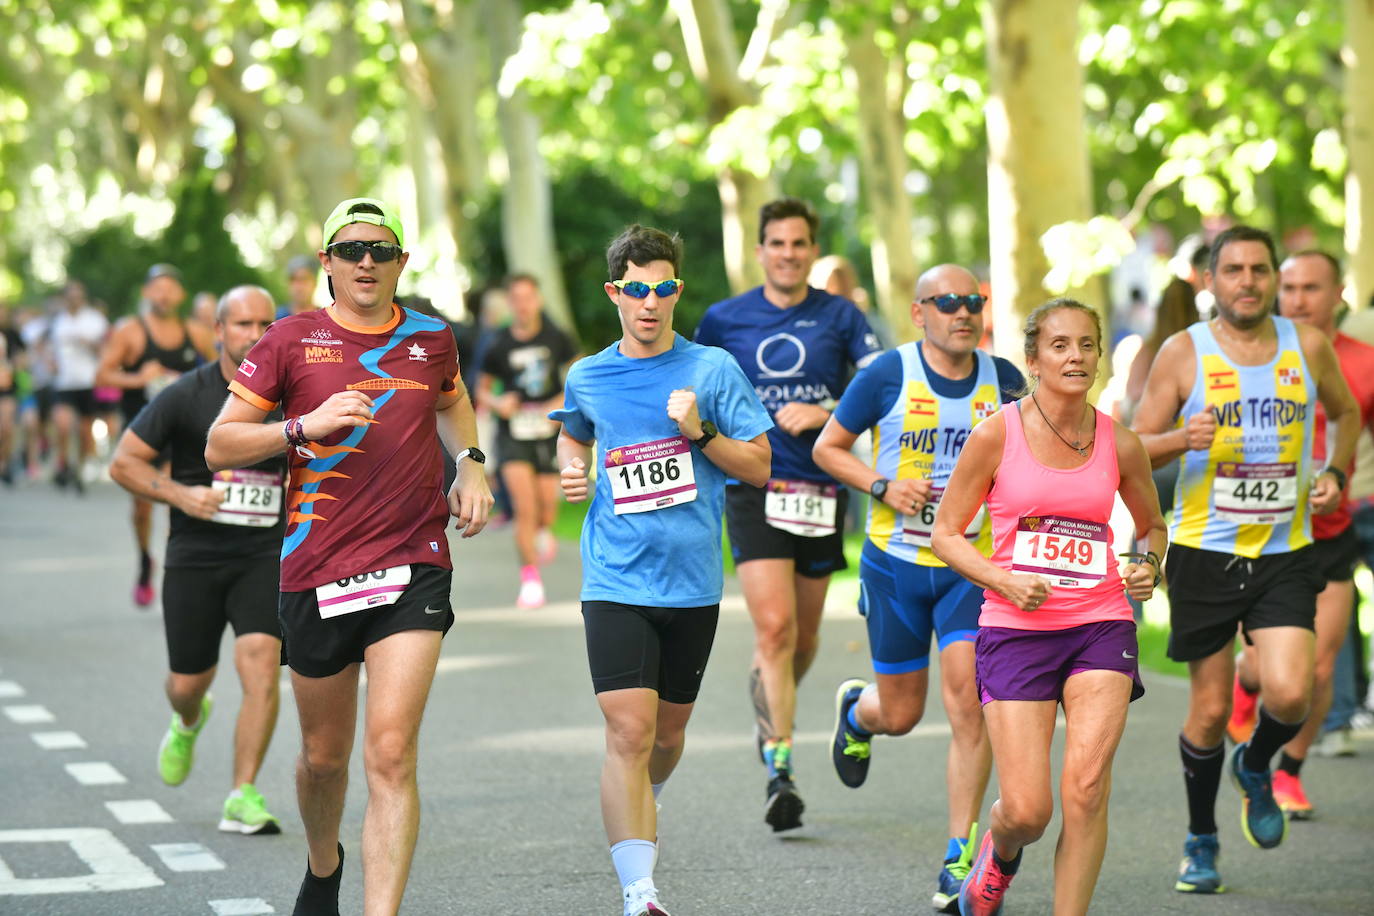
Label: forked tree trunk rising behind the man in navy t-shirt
xmin=672 ymin=0 xmax=786 ymax=293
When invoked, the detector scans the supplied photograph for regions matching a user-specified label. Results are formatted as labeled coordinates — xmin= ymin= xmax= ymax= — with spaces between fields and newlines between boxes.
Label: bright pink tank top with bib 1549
xmin=978 ymin=400 xmax=1132 ymax=630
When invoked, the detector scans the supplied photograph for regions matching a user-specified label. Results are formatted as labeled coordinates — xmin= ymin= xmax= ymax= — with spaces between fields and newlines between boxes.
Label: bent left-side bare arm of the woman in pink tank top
xmin=930 ymin=417 xmax=1050 ymax=610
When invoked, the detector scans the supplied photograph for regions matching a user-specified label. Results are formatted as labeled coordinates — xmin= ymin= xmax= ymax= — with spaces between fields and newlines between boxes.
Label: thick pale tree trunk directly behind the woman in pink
xmin=982 ymin=0 xmax=1112 ymax=374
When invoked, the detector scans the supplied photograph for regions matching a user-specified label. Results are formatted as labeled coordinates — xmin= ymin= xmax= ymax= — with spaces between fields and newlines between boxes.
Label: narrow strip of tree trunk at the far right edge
xmin=1342 ymin=0 xmax=1374 ymax=309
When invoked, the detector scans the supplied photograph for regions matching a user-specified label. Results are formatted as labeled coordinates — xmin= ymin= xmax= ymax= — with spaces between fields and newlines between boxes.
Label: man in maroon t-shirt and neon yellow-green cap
xmin=205 ymin=198 xmax=492 ymax=916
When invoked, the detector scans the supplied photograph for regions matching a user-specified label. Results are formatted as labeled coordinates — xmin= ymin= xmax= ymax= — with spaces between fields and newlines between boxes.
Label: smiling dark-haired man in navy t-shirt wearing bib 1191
xmin=697 ymin=198 xmax=882 ymax=831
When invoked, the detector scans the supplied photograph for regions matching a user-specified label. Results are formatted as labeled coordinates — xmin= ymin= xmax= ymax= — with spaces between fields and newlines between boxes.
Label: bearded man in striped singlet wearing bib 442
xmin=1135 ymin=225 xmax=1360 ymax=894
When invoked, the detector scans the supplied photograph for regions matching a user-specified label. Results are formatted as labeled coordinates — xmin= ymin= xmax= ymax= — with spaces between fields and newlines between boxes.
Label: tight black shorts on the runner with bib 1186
xmin=583 ymin=602 xmax=720 ymax=703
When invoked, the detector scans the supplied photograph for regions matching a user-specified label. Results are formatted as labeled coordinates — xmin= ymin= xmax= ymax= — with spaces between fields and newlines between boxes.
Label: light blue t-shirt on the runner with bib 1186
xmin=548 ymin=334 xmax=772 ymax=607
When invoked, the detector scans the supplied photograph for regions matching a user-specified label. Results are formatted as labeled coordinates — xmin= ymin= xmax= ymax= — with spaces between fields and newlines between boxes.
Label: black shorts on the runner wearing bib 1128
xmin=162 ymin=553 xmax=282 ymax=674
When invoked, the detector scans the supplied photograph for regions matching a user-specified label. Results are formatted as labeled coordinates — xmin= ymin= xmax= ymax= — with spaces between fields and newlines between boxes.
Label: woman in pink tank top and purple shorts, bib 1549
xmin=932 ymin=299 xmax=1165 ymax=916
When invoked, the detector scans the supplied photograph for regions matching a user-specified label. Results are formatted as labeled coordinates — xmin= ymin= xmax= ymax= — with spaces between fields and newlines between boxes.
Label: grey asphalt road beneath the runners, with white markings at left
xmin=0 ymin=483 xmax=1374 ymax=916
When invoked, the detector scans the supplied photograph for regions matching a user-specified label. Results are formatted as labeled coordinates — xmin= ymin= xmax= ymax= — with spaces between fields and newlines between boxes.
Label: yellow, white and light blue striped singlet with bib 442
xmin=1169 ymin=317 xmax=1316 ymax=559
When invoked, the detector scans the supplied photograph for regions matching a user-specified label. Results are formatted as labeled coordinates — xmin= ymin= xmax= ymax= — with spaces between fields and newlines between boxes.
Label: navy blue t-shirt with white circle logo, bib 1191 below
xmin=697 ymin=287 xmax=882 ymax=483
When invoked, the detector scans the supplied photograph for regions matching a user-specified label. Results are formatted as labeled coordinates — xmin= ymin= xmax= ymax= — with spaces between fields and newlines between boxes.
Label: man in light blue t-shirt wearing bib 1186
xmin=548 ymin=224 xmax=772 ymax=916
